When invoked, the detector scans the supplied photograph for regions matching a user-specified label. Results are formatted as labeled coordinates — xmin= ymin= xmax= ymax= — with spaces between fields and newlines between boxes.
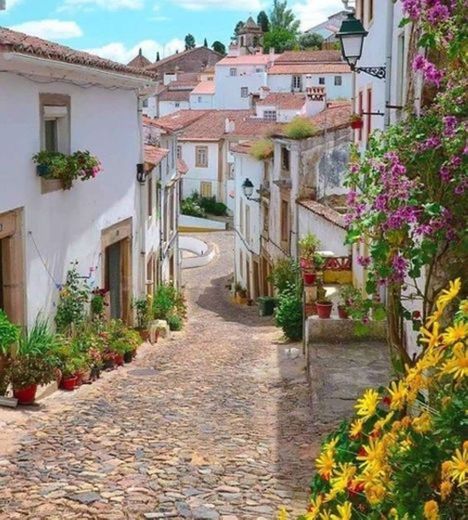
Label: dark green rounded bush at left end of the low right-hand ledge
xmin=275 ymin=284 xmax=304 ymax=341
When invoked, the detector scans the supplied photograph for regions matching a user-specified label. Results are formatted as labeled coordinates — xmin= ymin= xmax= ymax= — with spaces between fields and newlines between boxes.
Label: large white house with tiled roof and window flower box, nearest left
xmin=0 ymin=29 xmax=174 ymax=325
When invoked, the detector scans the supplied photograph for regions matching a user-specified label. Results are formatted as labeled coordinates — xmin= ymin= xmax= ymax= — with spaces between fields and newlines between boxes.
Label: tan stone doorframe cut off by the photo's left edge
xmin=0 ymin=208 xmax=26 ymax=326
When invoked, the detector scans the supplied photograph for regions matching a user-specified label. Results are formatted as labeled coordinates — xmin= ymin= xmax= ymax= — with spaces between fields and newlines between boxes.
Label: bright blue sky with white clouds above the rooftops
xmin=0 ymin=0 xmax=343 ymax=63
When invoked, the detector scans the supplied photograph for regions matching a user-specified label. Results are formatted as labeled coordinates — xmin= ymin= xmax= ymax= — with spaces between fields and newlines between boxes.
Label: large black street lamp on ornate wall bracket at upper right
xmin=336 ymin=13 xmax=386 ymax=79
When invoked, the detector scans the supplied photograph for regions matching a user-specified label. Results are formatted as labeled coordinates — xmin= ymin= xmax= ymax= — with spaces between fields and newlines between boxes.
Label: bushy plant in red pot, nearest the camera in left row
xmin=7 ymin=355 xmax=55 ymax=404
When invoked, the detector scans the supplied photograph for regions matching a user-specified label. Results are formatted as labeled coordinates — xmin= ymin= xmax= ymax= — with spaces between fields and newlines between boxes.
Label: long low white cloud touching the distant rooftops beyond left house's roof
xmin=85 ymin=38 xmax=185 ymax=63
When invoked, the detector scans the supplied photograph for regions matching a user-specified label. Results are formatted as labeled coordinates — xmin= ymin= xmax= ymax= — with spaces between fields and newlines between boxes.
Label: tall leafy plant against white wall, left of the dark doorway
xmin=55 ymin=262 xmax=89 ymax=333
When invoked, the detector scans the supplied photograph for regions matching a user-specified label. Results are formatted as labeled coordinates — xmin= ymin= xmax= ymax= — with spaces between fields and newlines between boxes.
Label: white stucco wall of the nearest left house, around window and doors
xmin=0 ymin=73 xmax=146 ymax=324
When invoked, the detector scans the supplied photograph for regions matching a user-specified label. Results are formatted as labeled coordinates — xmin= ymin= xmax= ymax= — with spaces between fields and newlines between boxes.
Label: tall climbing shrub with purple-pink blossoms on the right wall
xmin=347 ymin=0 xmax=468 ymax=363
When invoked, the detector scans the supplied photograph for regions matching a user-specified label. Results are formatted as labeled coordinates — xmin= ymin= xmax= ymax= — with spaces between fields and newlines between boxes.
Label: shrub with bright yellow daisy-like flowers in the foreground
xmin=290 ymin=279 xmax=468 ymax=520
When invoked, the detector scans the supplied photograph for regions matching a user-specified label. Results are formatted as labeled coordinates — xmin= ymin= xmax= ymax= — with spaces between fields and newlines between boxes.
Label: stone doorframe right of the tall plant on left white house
xmin=101 ymin=217 xmax=133 ymax=325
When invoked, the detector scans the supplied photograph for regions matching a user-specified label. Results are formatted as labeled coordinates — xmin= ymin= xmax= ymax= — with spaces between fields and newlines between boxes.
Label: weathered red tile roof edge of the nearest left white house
xmin=0 ymin=27 xmax=154 ymax=79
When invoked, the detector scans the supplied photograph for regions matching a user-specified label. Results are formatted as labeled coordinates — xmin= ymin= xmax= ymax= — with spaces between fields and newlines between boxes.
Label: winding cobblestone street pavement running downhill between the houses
xmin=0 ymin=232 xmax=318 ymax=520
